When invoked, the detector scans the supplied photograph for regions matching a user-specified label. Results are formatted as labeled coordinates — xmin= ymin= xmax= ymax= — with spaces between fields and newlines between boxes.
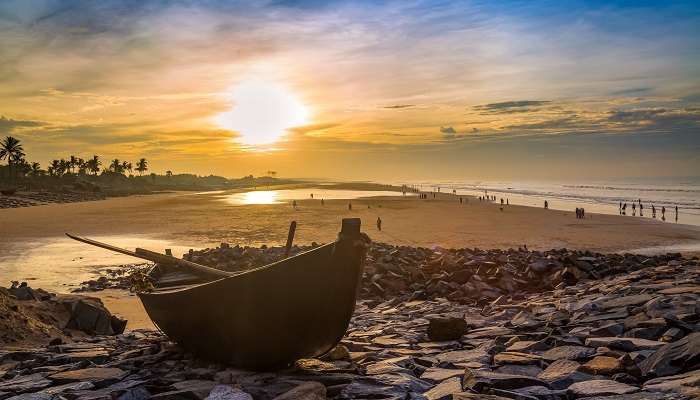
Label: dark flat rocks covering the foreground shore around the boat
xmin=0 ymin=244 xmax=700 ymax=400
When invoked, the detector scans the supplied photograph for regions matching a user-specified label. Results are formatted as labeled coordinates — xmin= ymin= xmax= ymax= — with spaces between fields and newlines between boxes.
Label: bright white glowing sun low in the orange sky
xmin=214 ymin=80 xmax=309 ymax=146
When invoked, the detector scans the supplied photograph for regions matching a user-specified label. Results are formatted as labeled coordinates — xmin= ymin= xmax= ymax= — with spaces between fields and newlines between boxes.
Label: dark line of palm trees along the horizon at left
xmin=0 ymin=136 xmax=152 ymax=177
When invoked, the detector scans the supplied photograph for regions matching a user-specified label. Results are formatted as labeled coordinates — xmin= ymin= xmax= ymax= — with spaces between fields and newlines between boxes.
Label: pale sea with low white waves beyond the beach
xmin=394 ymin=177 xmax=700 ymax=226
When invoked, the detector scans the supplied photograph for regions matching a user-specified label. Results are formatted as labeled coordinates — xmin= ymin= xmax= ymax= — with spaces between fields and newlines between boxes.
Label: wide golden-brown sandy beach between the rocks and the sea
xmin=0 ymin=184 xmax=700 ymax=329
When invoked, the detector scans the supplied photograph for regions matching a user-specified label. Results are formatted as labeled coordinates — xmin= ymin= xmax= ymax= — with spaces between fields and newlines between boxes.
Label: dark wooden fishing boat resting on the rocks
xmin=68 ymin=219 xmax=368 ymax=369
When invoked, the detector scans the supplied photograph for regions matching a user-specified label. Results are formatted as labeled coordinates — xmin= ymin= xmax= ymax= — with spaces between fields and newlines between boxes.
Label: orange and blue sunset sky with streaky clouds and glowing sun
xmin=0 ymin=0 xmax=700 ymax=180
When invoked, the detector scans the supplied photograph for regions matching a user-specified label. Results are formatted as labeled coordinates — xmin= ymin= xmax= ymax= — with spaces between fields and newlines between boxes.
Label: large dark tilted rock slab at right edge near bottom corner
xmin=640 ymin=332 xmax=700 ymax=377
